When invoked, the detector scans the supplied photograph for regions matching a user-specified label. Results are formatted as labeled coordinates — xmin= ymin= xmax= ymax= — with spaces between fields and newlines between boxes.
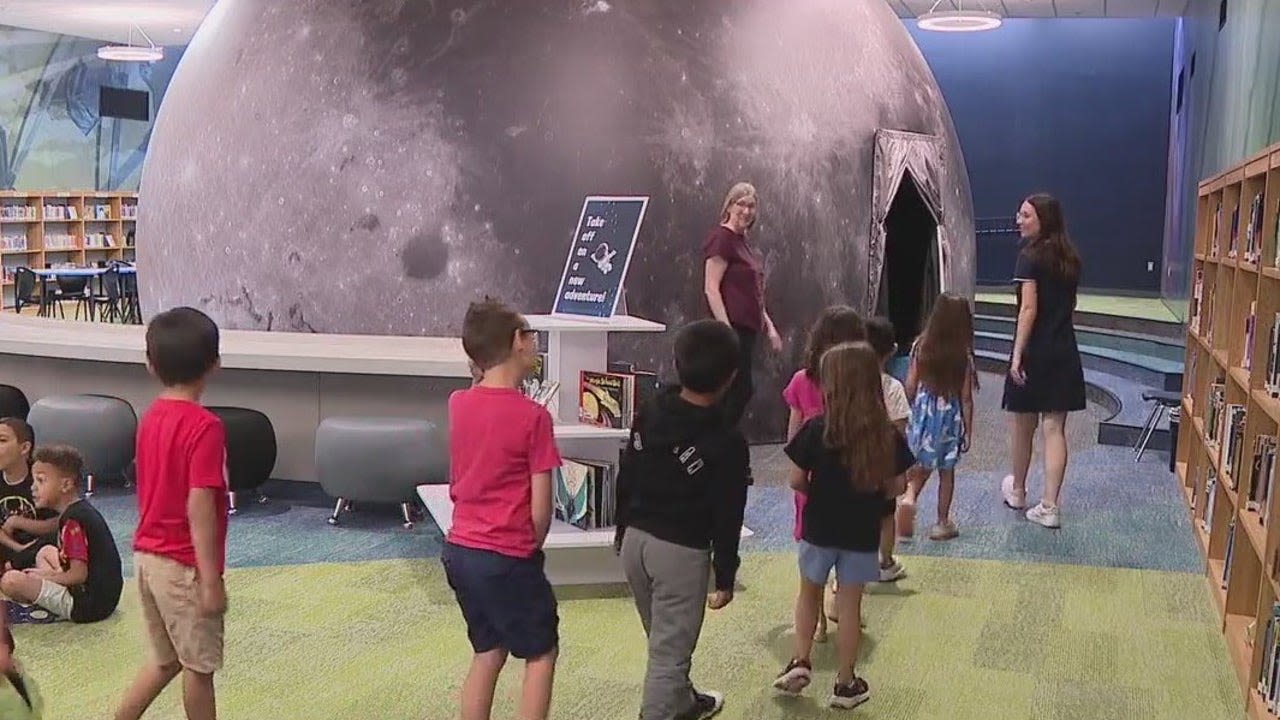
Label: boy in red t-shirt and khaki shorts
xmin=115 ymin=307 xmax=227 ymax=720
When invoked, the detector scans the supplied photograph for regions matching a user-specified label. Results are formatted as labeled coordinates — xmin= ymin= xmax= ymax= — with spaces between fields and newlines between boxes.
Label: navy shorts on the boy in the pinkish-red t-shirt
xmin=440 ymin=542 xmax=559 ymax=660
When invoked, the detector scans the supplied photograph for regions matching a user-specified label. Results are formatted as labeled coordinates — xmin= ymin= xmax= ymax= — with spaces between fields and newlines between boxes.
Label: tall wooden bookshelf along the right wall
xmin=1175 ymin=143 xmax=1280 ymax=720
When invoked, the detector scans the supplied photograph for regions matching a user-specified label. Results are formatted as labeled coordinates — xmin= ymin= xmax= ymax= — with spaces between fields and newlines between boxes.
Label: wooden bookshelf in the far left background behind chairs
xmin=0 ymin=190 xmax=138 ymax=307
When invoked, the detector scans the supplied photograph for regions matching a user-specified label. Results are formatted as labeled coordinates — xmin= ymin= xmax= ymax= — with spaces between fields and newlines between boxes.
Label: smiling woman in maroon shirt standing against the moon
xmin=703 ymin=182 xmax=782 ymax=425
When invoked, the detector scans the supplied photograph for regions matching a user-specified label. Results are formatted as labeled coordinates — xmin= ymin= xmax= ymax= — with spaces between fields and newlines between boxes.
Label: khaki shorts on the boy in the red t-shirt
xmin=133 ymin=552 xmax=223 ymax=675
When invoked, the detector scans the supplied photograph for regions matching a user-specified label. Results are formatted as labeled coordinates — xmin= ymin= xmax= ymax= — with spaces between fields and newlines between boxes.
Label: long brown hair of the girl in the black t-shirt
xmin=822 ymin=342 xmax=897 ymax=492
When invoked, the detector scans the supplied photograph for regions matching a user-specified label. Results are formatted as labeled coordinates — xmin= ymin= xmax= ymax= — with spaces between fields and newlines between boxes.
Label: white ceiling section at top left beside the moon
xmin=0 ymin=0 xmax=216 ymax=45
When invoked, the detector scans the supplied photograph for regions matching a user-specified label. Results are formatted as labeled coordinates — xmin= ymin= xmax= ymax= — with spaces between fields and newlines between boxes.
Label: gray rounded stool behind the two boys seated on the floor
xmin=27 ymin=395 xmax=138 ymax=496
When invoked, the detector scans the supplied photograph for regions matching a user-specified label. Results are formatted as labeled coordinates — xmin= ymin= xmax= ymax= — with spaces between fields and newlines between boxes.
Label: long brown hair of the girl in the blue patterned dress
xmin=915 ymin=292 xmax=973 ymax=397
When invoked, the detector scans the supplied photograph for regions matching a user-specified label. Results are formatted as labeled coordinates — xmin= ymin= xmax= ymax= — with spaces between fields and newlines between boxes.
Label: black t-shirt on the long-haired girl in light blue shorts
xmin=786 ymin=415 xmax=915 ymax=552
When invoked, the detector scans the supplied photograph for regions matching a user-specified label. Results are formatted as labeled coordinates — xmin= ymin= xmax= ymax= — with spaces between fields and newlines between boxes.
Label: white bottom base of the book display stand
xmin=417 ymin=484 xmax=754 ymax=585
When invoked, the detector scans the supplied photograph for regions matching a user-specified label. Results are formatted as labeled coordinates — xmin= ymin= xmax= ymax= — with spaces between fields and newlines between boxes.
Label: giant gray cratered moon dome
xmin=138 ymin=0 xmax=974 ymax=438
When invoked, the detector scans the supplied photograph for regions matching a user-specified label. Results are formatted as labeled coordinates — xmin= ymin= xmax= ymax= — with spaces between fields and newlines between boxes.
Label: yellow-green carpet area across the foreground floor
xmin=14 ymin=553 xmax=1243 ymax=720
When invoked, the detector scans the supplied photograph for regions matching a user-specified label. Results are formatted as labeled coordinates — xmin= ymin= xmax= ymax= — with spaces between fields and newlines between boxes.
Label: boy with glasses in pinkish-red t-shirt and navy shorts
xmin=440 ymin=300 xmax=561 ymax=720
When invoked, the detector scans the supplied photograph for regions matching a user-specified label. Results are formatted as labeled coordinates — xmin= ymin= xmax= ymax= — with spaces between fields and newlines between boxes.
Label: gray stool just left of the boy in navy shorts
xmin=316 ymin=418 xmax=448 ymax=529
